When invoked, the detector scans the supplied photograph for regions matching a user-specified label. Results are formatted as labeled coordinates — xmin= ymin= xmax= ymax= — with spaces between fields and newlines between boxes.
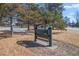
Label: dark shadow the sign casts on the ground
xmin=16 ymin=40 xmax=47 ymax=48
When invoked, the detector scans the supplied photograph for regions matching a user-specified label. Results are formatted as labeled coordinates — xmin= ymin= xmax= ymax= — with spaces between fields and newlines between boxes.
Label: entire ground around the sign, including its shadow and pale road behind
xmin=0 ymin=27 xmax=79 ymax=56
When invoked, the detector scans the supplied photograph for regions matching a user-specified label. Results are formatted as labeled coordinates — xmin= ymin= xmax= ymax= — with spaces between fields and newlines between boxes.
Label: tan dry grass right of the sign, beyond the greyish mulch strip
xmin=54 ymin=30 xmax=79 ymax=47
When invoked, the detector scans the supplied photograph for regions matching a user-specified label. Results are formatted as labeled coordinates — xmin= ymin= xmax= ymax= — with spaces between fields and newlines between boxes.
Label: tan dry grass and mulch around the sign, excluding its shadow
xmin=0 ymin=31 xmax=79 ymax=56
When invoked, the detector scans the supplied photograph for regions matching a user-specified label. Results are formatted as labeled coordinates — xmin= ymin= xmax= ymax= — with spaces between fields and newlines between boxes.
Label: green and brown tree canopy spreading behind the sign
xmin=0 ymin=3 xmax=66 ymax=30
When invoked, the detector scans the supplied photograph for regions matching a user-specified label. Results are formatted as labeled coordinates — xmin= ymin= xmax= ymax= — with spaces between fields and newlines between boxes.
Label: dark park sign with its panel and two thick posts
xmin=34 ymin=25 xmax=52 ymax=46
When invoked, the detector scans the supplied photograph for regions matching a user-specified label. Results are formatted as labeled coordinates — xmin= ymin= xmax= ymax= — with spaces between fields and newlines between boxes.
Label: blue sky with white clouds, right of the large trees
xmin=63 ymin=3 xmax=79 ymax=22
